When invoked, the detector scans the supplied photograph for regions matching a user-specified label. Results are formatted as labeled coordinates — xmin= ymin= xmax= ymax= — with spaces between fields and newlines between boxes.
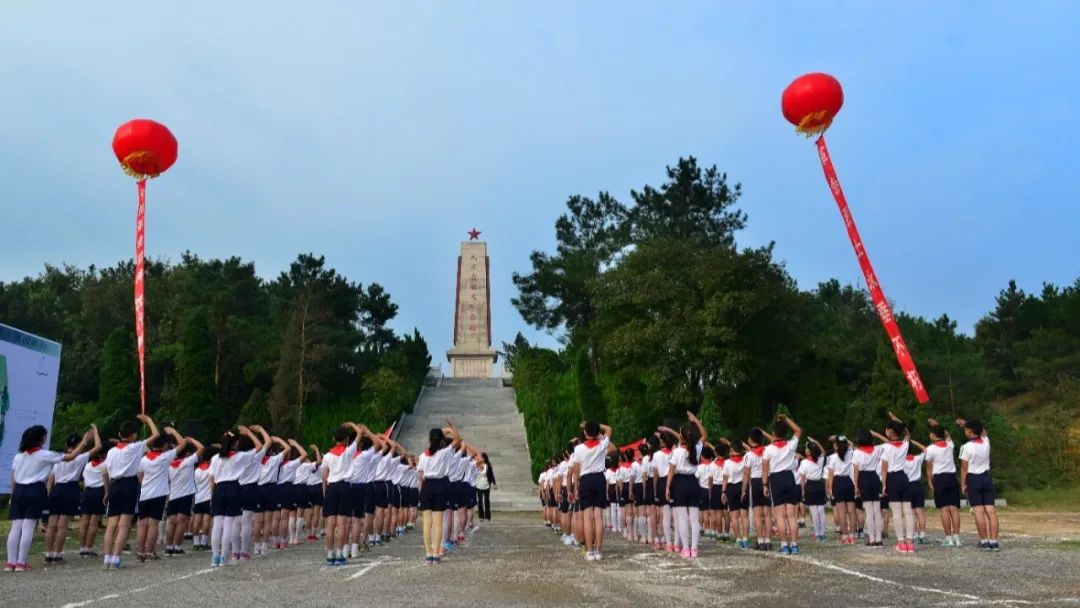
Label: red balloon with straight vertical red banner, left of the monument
xmin=112 ymin=119 xmax=177 ymax=414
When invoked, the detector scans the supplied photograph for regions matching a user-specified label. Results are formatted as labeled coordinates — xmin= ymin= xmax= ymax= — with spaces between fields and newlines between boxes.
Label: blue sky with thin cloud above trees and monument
xmin=0 ymin=1 xmax=1080 ymax=369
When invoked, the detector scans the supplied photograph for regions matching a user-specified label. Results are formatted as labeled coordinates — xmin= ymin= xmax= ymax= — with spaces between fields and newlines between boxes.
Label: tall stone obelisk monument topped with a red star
xmin=446 ymin=228 xmax=499 ymax=378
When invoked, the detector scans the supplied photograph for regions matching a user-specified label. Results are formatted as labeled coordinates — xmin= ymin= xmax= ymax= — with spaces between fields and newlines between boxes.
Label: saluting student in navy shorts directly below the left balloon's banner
xmin=103 ymin=414 xmax=160 ymax=570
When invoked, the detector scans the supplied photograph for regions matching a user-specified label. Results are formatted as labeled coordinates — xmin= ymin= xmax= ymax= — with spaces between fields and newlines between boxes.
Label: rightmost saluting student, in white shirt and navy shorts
xmin=956 ymin=419 xmax=1001 ymax=551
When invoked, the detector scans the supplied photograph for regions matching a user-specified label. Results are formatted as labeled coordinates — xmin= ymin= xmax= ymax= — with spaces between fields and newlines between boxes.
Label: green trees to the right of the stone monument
xmin=503 ymin=158 xmax=1080 ymax=487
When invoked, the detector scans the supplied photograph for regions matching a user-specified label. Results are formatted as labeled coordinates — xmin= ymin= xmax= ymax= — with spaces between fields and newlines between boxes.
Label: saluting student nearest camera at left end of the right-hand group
xmin=570 ymin=420 xmax=618 ymax=562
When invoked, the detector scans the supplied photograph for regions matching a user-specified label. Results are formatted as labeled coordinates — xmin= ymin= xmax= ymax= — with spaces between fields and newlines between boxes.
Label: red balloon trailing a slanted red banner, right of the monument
xmin=780 ymin=72 xmax=930 ymax=404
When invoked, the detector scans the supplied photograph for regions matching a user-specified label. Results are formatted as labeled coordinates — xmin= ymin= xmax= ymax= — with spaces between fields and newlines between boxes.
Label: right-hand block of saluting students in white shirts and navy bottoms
xmin=538 ymin=414 xmax=1000 ymax=557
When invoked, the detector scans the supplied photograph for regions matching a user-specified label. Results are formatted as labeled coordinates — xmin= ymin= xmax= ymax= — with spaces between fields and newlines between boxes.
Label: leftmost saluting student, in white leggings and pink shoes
xmin=4 ymin=424 xmax=91 ymax=572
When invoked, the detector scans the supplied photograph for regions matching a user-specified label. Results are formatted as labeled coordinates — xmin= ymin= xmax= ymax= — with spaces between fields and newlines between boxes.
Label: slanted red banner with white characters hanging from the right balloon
xmin=818 ymin=135 xmax=930 ymax=404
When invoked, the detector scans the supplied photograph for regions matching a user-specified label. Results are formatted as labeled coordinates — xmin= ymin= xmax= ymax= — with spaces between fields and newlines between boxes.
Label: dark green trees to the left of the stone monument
xmin=0 ymin=253 xmax=431 ymax=444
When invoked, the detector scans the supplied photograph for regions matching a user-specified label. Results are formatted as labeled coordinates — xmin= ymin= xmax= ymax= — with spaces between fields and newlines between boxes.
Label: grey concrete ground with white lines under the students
xmin=8 ymin=513 xmax=1080 ymax=608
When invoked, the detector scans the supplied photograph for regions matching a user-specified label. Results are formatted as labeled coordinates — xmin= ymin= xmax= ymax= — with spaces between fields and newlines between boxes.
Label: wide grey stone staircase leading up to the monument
xmin=397 ymin=378 xmax=540 ymax=511
